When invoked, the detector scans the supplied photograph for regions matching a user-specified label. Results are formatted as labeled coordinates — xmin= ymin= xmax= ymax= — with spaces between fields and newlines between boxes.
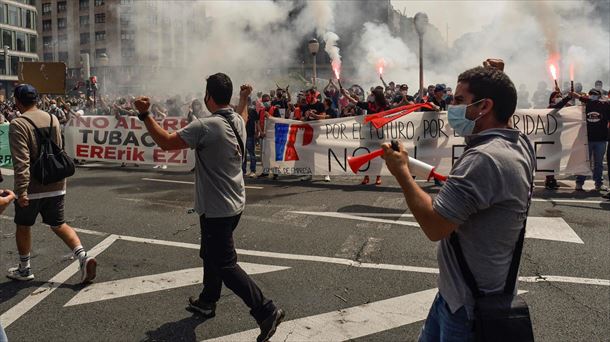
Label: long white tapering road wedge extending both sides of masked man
xmin=290 ymin=211 xmax=584 ymax=243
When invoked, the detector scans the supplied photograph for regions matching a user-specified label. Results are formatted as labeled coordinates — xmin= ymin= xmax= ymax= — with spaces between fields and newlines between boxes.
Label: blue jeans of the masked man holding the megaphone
xmin=419 ymin=293 xmax=474 ymax=342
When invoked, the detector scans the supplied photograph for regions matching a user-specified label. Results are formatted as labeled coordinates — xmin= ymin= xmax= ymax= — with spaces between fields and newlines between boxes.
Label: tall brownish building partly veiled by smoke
xmin=36 ymin=0 xmax=196 ymax=93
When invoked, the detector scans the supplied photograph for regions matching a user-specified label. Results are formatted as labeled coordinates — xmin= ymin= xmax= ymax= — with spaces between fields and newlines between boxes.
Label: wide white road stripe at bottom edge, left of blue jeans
xmin=207 ymin=289 xmax=438 ymax=342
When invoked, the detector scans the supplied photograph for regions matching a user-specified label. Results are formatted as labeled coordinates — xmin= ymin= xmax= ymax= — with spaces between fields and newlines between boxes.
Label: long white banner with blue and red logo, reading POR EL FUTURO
xmin=262 ymin=107 xmax=591 ymax=177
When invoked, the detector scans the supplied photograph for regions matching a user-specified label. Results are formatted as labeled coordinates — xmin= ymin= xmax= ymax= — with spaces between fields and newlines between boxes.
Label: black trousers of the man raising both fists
xmin=199 ymin=214 xmax=275 ymax=323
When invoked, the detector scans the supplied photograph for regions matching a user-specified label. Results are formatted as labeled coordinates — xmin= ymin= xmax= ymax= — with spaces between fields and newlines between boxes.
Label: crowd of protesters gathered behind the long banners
xmin=0 ymin=77 xmax=610 ymax=197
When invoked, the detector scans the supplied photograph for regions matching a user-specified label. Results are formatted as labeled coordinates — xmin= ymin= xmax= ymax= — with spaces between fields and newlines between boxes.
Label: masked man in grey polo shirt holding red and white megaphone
xmin=383 ymin=66 xmax=536 ymax=341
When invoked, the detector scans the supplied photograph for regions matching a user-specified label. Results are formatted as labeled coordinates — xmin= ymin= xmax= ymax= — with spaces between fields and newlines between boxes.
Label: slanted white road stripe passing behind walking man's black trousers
xmin=64 ymin=262 xmax=290 ymax=306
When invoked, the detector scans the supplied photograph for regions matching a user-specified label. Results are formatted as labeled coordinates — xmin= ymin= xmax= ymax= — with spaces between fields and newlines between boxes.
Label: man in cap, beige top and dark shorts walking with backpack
xmin=7 ymin=84 xmax=97 ymax=283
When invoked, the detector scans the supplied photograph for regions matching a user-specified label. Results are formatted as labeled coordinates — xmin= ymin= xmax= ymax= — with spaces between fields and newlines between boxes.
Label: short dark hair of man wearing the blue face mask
xmin=458 ymin=66 xmax=517 ymax=123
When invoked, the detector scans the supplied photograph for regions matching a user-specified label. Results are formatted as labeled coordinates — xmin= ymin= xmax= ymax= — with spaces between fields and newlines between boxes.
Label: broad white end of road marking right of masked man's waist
xmin=525 ymin=217 xmax=584 ymax=244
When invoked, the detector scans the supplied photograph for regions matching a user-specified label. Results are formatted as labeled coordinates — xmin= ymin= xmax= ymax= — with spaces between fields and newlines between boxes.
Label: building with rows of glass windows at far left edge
xmin=0 ymin=0 xmax=39 ymax=100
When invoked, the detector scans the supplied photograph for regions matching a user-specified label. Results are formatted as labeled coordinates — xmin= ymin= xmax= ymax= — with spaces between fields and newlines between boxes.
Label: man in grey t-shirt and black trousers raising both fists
xmin=135 ymin=73 xmax=284 ymax=342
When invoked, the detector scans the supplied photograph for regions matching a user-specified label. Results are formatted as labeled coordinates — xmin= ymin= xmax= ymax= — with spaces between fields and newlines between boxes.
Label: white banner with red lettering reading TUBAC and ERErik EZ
xmin=64 ymin=116 xmax=195 ymax=167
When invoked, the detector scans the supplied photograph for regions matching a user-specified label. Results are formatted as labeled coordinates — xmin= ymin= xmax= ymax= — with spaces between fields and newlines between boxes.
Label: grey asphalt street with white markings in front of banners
xmin=0 ymin=164 xmax=610 ymax=341
